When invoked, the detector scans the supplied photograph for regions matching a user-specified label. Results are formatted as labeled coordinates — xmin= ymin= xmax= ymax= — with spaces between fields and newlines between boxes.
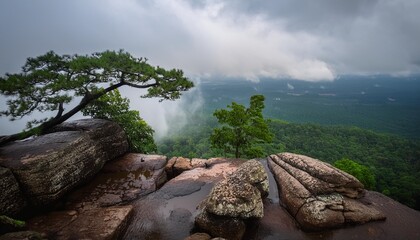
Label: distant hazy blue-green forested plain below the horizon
xmin=198 ymin=75 xmax=420 ymax=139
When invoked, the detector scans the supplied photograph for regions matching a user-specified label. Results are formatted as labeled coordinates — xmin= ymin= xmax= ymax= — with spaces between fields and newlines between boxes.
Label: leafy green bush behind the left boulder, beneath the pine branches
xmin=82 ymin=89 xmax=157 ymax=153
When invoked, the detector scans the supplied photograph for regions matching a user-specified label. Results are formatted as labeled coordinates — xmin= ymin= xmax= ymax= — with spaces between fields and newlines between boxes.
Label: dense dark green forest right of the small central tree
xmin=265 ymin=120 xmax=420 ymax=209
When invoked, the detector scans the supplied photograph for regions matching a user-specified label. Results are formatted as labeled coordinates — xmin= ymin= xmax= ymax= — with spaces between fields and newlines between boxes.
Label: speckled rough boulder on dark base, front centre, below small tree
xmin=195 ymin=160 xmax=269 ymax=239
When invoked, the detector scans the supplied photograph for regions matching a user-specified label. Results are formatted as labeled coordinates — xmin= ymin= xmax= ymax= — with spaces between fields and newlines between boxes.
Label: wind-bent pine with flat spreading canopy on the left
xmin=0 ymin=50 xmax=193 ymax=135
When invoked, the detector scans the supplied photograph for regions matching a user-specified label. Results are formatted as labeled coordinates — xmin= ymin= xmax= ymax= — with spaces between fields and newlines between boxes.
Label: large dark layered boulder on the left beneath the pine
xmin=0 ymin=119 xmax=128 ymax=207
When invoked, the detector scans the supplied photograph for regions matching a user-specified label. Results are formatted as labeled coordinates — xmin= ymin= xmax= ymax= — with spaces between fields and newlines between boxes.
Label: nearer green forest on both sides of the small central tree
xmin=158 ymin=115 xmax=420 ymax=210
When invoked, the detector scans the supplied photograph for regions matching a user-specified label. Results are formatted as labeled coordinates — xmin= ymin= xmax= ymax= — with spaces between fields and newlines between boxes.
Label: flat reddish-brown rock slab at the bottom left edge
xmin=28 ymin=206 xmax=133 ymax=240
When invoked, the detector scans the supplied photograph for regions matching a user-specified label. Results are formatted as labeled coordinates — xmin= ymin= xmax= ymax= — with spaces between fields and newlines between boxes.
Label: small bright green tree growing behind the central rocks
xmin=210 ymin=95 xmax=273 ymax=158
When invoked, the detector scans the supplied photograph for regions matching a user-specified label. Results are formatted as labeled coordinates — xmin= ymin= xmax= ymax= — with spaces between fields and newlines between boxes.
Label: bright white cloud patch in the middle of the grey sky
xmin=98 ymin=0 xmax=335 ymax=81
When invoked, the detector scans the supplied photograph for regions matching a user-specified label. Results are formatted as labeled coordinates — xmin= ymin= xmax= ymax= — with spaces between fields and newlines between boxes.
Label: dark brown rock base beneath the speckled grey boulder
xmin=195 ymin=210 xmax=246 ymax=240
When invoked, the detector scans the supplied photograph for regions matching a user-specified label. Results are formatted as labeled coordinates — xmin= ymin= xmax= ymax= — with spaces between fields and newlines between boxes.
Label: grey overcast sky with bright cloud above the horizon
xmin=0 ymin=0 xmax=420 ymax=137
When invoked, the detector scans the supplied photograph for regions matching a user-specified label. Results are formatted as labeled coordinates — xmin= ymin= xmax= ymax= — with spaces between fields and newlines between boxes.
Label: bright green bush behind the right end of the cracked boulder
xmin=334 ymin=158 xmax=376 ymax=190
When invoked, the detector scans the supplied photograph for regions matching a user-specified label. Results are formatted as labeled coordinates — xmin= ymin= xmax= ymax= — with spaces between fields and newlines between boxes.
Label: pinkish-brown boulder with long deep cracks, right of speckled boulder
xmin=268 ymin=153 xmax=385 ymax=231
